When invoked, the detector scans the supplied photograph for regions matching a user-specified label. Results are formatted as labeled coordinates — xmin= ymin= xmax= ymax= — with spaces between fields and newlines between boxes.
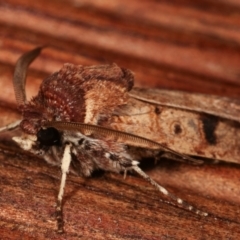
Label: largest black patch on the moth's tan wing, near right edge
xmin=200 ymin=114 xmax=219 ymax=145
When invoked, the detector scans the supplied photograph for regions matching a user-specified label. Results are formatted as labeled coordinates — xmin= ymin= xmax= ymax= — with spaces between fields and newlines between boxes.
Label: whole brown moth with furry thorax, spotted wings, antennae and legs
xmin=0 ymin=47 xmax=240 ymax=233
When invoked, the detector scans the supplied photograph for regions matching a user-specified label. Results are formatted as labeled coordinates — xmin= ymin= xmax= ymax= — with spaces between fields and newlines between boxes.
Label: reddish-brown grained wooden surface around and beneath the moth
xmin=0 ymin=0 xmax=240 ymax=239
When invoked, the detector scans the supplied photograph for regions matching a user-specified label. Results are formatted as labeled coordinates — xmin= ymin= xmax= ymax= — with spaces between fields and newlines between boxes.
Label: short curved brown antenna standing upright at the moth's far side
xmin=13 ymin=47 xmax=43 ymax=105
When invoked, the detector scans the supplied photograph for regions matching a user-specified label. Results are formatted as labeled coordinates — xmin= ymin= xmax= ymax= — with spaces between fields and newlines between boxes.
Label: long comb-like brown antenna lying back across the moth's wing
xmin=45 ymin=121 xmax=203 ymax=164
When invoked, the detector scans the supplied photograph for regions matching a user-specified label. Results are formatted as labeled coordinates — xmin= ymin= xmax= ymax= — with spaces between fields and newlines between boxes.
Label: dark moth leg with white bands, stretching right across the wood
xmin=131 ymin=166 xmax=208 ymax=217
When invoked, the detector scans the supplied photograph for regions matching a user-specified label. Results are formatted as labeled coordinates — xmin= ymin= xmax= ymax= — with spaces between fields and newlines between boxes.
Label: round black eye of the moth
xmin=37 ymin=127 xmax=61 ymax=146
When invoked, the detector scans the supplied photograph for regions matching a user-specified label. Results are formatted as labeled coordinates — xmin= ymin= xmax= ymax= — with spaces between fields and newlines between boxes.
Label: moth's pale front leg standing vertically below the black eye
xmin=56 ymin=144 xmax=72 ymax=233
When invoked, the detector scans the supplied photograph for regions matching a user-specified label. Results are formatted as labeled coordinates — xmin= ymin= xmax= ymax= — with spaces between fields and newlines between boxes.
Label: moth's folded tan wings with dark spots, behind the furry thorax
xmin=107 ymin=89 xmax=240 ymax=163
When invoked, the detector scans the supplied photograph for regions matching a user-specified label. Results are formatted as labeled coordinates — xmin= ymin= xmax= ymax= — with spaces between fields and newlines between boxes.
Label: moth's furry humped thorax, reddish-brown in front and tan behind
xmin=20 ymin=63 xmax=133 ymax=134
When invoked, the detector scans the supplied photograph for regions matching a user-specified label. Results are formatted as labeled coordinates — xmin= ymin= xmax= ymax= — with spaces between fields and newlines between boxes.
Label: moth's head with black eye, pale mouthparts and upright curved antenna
xmin=13 ymin=47 xmax=61 ymax=151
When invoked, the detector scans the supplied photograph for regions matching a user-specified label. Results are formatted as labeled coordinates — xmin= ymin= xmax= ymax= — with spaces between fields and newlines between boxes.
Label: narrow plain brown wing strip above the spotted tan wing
xmin=129 ymin=88 xmax=240 ymax=122
